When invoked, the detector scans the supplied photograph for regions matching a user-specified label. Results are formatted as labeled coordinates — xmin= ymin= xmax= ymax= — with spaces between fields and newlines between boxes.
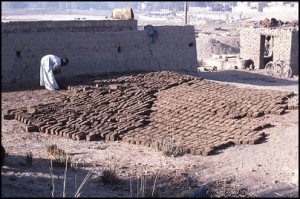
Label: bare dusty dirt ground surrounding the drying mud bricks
xmin=1 ymin=70 xmax=299 ymax=197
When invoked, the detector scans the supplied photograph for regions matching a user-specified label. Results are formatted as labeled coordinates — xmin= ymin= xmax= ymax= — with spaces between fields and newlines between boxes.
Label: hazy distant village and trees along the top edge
xmin=1 ymin=1 xmax=299 ymax=13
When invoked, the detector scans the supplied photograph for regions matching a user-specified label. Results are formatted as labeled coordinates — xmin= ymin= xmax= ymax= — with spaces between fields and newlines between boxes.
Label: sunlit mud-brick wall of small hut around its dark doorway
xmin=240 ymin=28 xmax=299 ymax=75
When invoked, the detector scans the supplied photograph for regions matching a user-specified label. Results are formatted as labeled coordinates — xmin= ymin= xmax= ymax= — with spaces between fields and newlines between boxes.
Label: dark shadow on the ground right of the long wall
xmin=198 ymin=70 xmax=299 ymax=86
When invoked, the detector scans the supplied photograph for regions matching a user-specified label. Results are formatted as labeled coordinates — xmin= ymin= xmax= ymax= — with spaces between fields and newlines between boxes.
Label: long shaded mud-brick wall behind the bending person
xmin=1 ymin=20 xmax=197 ymax=86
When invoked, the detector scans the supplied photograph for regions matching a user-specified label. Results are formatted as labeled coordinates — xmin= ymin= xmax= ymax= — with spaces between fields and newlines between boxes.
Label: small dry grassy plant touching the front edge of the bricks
xmin=151 ymin=139 xmax=184 ymax=157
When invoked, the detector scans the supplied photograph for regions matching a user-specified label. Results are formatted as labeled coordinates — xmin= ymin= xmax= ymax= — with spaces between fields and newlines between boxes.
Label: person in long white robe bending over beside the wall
xmin=40 ymin=55 xmax=69 ymax=91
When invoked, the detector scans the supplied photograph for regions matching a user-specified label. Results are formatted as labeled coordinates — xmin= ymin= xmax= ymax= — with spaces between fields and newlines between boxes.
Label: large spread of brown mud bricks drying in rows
xmin=4 ymin=71 xmax=298 ymax=155
